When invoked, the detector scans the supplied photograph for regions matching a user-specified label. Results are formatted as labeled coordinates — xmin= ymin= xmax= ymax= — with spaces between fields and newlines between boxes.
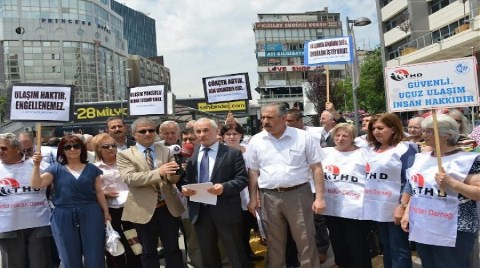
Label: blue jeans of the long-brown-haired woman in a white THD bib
xmin=377 ymin=222 xmax=412 ymax=268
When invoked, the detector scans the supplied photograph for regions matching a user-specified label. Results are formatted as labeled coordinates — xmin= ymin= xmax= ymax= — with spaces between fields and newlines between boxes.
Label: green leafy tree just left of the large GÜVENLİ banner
xmin=357 ymin=48 xmax=386 ymax=113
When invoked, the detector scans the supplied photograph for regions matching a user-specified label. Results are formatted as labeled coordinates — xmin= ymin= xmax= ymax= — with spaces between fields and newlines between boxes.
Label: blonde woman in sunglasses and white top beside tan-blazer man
xmin=91 ymin=133 xmax=142 ymax=268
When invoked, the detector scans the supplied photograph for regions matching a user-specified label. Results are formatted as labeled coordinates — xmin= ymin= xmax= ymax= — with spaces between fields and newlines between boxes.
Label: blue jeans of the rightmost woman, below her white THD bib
xmin=417 ymin=232 xmax=477 ymax=268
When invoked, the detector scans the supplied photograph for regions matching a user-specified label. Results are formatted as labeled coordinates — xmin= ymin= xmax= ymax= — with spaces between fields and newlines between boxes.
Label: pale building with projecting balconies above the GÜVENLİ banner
xmin=376 ymin=0 xmax=480 ymax=66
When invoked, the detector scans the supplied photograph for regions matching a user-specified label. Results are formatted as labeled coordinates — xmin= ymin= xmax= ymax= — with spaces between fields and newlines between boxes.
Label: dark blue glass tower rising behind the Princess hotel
xmin=112 ymin=0 xmax=157 ymax=58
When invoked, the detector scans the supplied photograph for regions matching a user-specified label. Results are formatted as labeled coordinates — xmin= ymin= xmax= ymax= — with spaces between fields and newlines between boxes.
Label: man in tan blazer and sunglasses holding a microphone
xmin=117 ymin=117 xmax=185 ymax=268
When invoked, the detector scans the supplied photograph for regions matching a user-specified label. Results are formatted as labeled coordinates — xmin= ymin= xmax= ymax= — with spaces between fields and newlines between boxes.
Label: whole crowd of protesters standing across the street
xmin=0 ymin=103 xmax=480 ymax=268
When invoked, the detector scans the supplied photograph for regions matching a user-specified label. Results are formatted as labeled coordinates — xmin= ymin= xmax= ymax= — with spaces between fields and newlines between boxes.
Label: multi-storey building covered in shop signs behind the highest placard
xmin=253 ymin=8 xmax=345 ymax=107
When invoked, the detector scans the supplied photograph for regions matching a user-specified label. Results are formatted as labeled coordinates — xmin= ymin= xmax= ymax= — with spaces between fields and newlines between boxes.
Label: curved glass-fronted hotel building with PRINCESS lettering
xmin=0 ymin=0 xmax=128 ymax=102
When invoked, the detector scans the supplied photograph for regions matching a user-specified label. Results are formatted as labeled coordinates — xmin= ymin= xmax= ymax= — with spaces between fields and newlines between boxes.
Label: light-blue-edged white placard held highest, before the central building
xmin=303 ymin=36 xmax=353 ymax=65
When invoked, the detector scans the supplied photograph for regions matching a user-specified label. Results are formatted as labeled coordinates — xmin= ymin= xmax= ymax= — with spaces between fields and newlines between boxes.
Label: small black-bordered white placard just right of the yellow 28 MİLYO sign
xmin=128 ymin=85 xmax=167 ymax=116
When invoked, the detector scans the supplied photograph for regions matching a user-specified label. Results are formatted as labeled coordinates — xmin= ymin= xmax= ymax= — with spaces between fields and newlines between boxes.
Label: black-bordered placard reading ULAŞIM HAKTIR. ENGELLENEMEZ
xmin=9 ymin=84 xmax=73 ymax=122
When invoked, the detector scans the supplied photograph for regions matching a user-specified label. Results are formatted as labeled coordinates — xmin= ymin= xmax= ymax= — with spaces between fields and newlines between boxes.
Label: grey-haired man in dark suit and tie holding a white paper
xmin=182 ymin=118 xmax=248 ymax=268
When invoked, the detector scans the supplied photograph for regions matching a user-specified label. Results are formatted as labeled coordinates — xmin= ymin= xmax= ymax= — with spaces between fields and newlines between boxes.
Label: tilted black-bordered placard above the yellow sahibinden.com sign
xmin=202 ymin=73 xmax=252 ymax=103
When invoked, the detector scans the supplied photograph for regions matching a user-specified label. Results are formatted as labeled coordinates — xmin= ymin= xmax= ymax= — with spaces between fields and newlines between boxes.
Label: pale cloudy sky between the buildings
xmin=118 ymin=0 xmax=380 ymax=102
